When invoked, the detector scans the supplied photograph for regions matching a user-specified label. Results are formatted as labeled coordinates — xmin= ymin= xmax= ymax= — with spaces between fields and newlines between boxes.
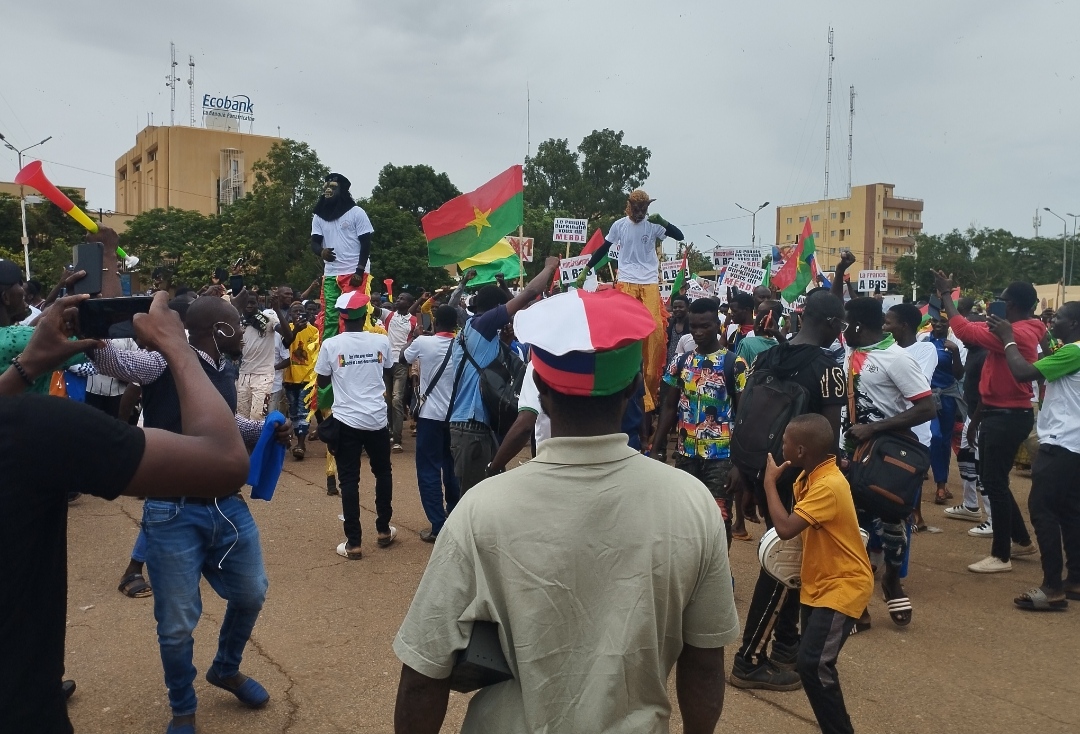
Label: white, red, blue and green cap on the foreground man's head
xmin=514 ymin=290 xmax=657 ymax=396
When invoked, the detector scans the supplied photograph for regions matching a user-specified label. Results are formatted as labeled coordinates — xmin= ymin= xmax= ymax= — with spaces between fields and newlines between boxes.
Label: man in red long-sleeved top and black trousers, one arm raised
xmin=934 ymin=271 xmax=1047 ymax=573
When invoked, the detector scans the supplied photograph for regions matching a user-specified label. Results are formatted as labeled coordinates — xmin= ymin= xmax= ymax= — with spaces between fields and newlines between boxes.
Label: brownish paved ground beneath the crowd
xmin=67 ymin=438 xmax=1080 ymax=734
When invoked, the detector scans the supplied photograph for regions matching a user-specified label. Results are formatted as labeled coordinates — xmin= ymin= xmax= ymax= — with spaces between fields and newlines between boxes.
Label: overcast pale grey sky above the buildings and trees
xmin=0 ymin=0 xmax=1080 ymax=252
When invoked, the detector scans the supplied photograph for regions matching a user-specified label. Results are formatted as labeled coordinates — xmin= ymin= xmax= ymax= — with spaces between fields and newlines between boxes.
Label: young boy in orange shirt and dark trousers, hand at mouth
xmin=765 ymin=413 xmax=874 ymax=734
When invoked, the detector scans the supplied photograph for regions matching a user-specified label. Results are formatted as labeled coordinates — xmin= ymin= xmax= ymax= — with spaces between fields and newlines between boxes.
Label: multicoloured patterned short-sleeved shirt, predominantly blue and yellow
xmin=664 ymin=349 xmax=731 ymax=460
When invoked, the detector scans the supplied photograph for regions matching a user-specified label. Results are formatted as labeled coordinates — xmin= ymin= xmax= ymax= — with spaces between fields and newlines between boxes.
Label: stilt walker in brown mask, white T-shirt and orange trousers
xmin=579 ymin=189 xmax=684 ymax=412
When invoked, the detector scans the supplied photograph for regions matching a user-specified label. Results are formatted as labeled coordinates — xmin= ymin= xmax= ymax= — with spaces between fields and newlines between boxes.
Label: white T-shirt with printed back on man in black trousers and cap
xmin=315 ymin=331 xmax=392 ymax=431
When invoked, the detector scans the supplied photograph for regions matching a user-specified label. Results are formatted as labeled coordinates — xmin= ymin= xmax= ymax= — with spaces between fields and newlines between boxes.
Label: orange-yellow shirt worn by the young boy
xmin=794 ymin=457 xmax=874 ymax=617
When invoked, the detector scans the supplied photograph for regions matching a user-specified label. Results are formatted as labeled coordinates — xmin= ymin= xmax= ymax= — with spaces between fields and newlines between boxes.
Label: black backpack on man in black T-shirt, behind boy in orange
xmin=731 ymin=364 xmax=810 ymax=477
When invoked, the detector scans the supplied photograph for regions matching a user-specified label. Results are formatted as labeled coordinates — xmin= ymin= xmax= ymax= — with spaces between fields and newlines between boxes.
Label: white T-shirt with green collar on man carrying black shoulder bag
xmin=845 ymin=344 xmax=930 ymax=446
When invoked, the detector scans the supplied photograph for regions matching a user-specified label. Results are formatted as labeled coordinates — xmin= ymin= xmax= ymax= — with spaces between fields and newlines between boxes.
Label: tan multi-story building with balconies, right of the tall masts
xmin=777 ymin=184 xmax=922 ymax=281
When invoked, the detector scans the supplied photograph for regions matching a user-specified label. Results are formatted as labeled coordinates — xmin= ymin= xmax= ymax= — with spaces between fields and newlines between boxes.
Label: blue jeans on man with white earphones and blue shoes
xmin=143 ymin=494 xmax=268 ymax=716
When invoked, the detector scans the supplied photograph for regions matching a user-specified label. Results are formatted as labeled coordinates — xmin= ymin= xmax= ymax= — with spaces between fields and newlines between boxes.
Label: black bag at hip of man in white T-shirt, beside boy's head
xmin=848 ymin=431 xmax=930 ymax=522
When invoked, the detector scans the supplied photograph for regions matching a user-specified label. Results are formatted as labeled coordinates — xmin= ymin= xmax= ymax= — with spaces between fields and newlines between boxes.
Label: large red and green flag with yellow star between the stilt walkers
xmin=420 ymin=165 xmax=523 ymax=268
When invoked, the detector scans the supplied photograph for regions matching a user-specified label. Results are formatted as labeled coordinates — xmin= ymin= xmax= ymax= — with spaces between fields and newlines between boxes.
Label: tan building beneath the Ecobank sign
xmin=116 ymin=125 xmax=280 ymax=214
